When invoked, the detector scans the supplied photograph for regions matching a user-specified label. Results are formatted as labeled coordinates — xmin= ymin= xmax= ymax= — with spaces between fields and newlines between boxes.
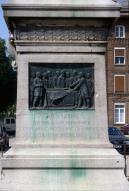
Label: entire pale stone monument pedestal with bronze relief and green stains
xmin=0 ymin=0 xmax=129 ymax=191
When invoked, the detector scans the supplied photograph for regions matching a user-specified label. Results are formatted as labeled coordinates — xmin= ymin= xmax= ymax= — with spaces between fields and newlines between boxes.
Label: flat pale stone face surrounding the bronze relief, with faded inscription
xmin=14 ymin=53 xmax=108 ymax=144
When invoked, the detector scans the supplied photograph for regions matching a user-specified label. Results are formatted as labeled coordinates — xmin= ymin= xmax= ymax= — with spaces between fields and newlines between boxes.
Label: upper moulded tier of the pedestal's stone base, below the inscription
xmin=2 ymin=148 xmax=124 ymax=169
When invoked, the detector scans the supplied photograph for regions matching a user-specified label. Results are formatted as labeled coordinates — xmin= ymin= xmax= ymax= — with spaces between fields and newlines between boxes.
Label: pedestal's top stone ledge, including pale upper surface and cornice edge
xmin=3 ymin=0 xmax=120 ymax=19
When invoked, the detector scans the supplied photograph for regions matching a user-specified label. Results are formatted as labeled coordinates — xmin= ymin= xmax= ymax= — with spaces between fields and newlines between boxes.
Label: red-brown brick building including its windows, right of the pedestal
xmin=106 ymin=0 xmax=129 ymax=127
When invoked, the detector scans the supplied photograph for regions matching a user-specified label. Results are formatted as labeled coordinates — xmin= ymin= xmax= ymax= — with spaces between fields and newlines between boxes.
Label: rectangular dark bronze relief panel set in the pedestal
xmin=29 ymin=63 xmax=94 ymax=109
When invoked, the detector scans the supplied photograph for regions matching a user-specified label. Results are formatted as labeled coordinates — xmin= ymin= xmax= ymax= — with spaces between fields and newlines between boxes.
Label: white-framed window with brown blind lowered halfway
xmin=114 ymin=48 xmax=125 ymax=65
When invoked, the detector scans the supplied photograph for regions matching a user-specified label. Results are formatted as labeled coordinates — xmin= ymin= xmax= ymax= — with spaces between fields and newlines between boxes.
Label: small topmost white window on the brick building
xmin=115 ymin=25 xmax=125 ymax=38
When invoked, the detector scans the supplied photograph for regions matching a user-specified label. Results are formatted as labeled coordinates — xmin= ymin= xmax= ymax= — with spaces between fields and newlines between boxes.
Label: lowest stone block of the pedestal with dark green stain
xmin=0 ymin=168 xmax=129 ymax=191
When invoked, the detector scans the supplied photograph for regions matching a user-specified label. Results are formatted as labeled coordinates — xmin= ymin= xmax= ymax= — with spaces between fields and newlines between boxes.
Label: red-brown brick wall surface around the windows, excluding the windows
xmin=106 ymin=18 xmax=129 ymax=127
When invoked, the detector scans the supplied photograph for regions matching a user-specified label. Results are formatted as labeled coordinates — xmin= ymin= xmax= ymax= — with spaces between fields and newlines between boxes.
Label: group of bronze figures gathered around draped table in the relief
xmin=30 ymin=70 xmax=94 ymax=109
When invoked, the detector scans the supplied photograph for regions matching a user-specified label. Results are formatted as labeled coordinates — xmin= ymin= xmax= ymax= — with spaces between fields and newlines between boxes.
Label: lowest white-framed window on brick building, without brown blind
xmin=114 ymin=103 xmax=125 ymax=124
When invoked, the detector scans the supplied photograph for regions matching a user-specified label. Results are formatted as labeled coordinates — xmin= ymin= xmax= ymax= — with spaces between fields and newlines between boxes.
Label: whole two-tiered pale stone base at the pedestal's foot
xmin=0 ymin=148 xmax=129 ymax=191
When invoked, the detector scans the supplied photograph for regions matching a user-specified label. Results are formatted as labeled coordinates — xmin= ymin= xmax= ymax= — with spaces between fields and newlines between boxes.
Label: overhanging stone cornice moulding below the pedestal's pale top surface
xmin=2 ymin=4 xmax=120 ymax=19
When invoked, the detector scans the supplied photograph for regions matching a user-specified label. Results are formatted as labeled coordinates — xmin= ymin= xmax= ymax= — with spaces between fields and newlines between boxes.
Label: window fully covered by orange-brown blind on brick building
xmin=114 ymin=75 xmax=125 ymax=93
